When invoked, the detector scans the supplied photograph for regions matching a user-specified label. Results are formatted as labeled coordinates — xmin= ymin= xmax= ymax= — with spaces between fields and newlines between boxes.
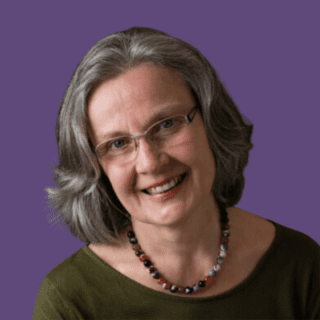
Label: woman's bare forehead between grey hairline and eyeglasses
xmin=88 ymin=65 xmax=194 ymax=142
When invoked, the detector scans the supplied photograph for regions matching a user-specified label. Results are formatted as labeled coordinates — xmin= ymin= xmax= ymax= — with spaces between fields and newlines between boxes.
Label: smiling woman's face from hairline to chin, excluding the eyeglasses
xmin=88 ymin=64 xmax=215 ymax=225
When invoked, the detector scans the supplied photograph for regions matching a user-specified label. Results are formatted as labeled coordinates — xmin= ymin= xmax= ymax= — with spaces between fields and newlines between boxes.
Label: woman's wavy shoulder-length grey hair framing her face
xmin=46 ymin=27 xmax=253 ymax=243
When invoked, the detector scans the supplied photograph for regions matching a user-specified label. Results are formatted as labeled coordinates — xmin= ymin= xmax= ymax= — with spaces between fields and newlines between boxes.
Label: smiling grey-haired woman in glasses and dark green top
xmin=33 ymin=28 xmax=320 ymax=319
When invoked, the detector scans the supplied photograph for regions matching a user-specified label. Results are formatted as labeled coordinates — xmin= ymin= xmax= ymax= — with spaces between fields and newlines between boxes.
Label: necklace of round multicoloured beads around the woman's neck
xmin=127 ymin=204 xmax=230 ymax=294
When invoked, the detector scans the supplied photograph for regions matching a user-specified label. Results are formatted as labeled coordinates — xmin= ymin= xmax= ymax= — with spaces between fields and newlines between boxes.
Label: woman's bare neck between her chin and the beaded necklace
xmin=132 ymin=197 xmax=221 ymax=286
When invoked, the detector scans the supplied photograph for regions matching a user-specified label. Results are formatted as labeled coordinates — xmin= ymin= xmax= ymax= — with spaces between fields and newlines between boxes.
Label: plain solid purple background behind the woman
xmin=0 ymin=0 xmax=320 ymax=319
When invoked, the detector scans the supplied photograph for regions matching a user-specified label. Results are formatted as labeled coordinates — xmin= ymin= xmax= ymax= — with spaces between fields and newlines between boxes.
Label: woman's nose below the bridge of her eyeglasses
xmin=135 ymin=138 xmax=168 ymax=174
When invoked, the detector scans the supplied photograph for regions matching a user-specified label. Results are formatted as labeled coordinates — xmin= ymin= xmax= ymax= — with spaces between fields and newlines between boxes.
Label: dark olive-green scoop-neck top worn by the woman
xmin=33 ymin=220 xmax=320 ymax=320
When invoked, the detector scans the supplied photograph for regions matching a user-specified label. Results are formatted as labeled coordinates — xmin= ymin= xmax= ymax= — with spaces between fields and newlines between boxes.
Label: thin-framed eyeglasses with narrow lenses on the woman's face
xmin=95 ymin=106 xmax=198 ymax=161
